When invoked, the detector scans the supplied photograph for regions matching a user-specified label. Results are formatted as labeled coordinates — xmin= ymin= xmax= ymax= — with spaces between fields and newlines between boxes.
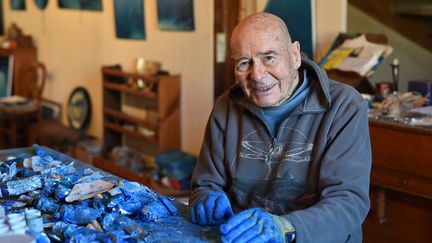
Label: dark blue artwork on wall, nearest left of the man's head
xmin=157 ymin=0 xmax=195 ymax=30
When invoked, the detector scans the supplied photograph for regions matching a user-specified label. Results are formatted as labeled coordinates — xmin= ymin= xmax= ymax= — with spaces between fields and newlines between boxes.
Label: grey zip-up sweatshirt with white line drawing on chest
xmin=191 ymin=58 xmax=371 ymax=243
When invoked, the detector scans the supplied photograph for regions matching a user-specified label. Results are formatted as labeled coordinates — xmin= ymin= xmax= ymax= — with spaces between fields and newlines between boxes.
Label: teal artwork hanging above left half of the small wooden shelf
xmin=114 ymin=0 xmax=146 ymax=39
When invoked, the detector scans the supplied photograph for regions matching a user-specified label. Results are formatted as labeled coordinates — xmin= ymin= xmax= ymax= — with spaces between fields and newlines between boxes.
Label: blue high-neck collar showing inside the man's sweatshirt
xmin=263 ymin=70 xmax=310 ymax=137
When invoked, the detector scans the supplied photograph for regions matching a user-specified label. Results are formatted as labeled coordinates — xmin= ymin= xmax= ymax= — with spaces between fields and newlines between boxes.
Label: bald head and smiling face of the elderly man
xmin=231 ymin=13 xmax=301 ymax=107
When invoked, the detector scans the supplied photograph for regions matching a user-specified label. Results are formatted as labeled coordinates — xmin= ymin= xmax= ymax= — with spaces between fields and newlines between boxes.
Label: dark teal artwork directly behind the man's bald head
xmin=264 ymin=0 xmax=313 ymax=58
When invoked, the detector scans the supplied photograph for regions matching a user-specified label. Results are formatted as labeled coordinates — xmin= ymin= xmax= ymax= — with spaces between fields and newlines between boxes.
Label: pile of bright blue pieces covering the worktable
xmin=0 ymin=146 xmax=218 ymax=242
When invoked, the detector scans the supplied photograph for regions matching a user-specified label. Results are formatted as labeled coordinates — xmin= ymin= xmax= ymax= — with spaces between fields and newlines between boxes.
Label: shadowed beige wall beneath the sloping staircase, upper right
xmin=348 ymin=6 xmax=432 ymax=91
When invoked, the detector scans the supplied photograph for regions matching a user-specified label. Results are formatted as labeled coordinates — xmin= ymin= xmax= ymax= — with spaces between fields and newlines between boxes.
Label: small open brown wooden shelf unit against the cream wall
xmin=95 ymin=67 xmax=180 ymax=186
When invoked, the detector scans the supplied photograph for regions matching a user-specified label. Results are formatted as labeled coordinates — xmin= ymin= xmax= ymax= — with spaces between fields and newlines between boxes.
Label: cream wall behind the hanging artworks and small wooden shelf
xmin=3 ymin=0 xmax=214 ymax=154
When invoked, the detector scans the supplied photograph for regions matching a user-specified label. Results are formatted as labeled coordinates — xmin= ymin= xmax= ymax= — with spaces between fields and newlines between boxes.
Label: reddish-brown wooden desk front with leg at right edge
xmin=369 ymin=120 xmax=432 ymax=222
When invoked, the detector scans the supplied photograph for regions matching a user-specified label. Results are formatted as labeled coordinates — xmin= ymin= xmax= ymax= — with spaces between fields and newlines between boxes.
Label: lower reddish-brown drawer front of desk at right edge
xmin=371 ymin=166 xmax=432 ymax=199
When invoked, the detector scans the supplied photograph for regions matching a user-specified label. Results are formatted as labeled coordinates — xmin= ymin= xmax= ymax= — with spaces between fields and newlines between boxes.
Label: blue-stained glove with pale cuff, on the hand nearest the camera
xmin=220 ymin=208 xmax=295 ymax=243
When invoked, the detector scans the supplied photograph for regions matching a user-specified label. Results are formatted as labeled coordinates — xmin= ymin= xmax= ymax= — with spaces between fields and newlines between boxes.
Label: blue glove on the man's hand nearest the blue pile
xmin=191 ymin=192 xmax=233 ymax=225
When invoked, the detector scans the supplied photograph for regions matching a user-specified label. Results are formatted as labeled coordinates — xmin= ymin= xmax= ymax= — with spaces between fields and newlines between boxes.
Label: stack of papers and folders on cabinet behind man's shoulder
xmin=321 ymin=34 xmax=393 ymax=76
